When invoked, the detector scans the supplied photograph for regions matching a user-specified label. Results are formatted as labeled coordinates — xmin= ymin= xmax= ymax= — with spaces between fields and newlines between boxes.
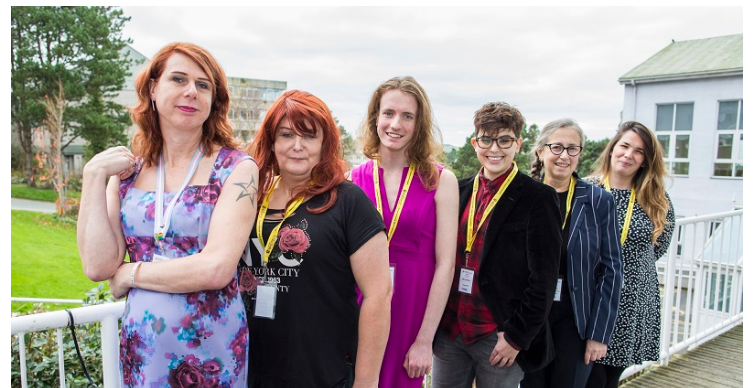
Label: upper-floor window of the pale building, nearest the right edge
xmin=714 ymin=100 xmax=743 ymax=178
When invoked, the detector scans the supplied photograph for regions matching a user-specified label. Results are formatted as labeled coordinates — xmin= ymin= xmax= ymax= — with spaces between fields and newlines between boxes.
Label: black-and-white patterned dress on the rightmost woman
xmin=587 ymin=178 xmax=675 ymax=367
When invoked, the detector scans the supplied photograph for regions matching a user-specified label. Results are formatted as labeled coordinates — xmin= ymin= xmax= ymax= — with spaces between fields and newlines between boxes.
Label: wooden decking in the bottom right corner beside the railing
xmin=620 ymin=324 xmax=743 ymax=388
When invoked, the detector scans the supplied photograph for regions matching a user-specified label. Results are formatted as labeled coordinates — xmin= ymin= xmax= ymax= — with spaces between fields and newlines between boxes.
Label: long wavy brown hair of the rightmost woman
xmin=593 ymin=121 xmax=669 ymax=244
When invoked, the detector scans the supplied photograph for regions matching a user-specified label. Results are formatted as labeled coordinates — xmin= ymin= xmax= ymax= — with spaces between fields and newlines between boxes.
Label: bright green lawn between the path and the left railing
xmin=10 ymin=210 xmax=106 ymax=311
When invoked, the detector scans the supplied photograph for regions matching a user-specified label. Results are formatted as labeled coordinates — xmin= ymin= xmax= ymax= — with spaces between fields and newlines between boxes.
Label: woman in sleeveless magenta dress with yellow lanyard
xmin=351 ymin=77 xmax=458 ymax=388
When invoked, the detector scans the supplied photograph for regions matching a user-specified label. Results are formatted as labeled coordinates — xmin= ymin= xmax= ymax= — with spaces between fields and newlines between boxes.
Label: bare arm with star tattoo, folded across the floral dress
xmin=110 ymin=160 xmax=259 ymax=297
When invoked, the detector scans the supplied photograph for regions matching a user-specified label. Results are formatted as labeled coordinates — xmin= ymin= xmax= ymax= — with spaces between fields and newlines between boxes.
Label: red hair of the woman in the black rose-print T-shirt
xmin=246 ymin=90 xmax=347 ymax=214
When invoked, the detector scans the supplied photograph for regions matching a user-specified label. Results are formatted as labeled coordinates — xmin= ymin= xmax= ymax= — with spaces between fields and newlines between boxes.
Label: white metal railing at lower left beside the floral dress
xmin=10 ymin=302 xmax=125 ymax=388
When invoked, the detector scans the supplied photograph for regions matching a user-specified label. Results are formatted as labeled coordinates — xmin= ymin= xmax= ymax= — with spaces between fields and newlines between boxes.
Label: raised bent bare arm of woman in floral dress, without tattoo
xmin=76 ymin=147 xmax=136 ymax=282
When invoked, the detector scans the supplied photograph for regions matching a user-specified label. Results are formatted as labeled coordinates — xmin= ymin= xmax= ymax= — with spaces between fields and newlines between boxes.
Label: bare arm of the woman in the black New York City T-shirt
xmin=350 ymin=233 xmax=392 ymax=388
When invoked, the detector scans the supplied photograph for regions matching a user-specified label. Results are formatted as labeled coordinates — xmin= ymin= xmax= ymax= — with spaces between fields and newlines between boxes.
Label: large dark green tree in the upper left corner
xmin=11 ymin=7 xmax=132 ymax=186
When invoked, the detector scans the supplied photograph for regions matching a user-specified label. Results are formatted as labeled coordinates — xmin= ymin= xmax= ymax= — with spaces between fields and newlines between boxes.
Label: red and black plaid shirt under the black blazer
xmin=439 ymin=168 xmax=517 ymax=348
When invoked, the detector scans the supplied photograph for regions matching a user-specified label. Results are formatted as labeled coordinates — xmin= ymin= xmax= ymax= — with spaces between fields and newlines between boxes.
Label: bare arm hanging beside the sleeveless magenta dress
xmin=403 ymin=169 xmax=459 ymax=378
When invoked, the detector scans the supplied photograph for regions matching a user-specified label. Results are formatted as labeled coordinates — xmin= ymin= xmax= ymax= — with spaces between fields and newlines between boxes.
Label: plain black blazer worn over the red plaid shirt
xmin=458 ymin=172 xmax=562 ymax=372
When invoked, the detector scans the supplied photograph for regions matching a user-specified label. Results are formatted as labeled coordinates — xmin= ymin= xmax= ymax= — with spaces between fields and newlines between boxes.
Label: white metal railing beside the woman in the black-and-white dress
xmin=622 ymin=209 xmax=744 ymax=379
